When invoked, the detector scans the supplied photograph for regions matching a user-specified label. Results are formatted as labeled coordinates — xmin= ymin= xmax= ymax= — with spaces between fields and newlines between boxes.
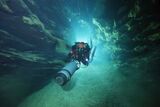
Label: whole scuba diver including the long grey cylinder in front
xmin=55 ymin=41 xmax=96 ymax=86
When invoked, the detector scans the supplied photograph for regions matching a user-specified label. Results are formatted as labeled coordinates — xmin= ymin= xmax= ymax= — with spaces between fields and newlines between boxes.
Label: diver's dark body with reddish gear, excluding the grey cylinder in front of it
xmin=68 ymin=42 xmax=91 ymax=66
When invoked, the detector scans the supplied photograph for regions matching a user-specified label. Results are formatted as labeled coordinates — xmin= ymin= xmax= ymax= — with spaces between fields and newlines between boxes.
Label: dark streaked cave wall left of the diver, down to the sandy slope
xmin=0 ymin=0 xmax=68 ymax=107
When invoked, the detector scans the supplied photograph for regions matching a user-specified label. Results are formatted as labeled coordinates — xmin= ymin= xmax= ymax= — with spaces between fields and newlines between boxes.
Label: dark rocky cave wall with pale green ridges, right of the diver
xmin=95 ymin=0 xmax=160 ymax=60
